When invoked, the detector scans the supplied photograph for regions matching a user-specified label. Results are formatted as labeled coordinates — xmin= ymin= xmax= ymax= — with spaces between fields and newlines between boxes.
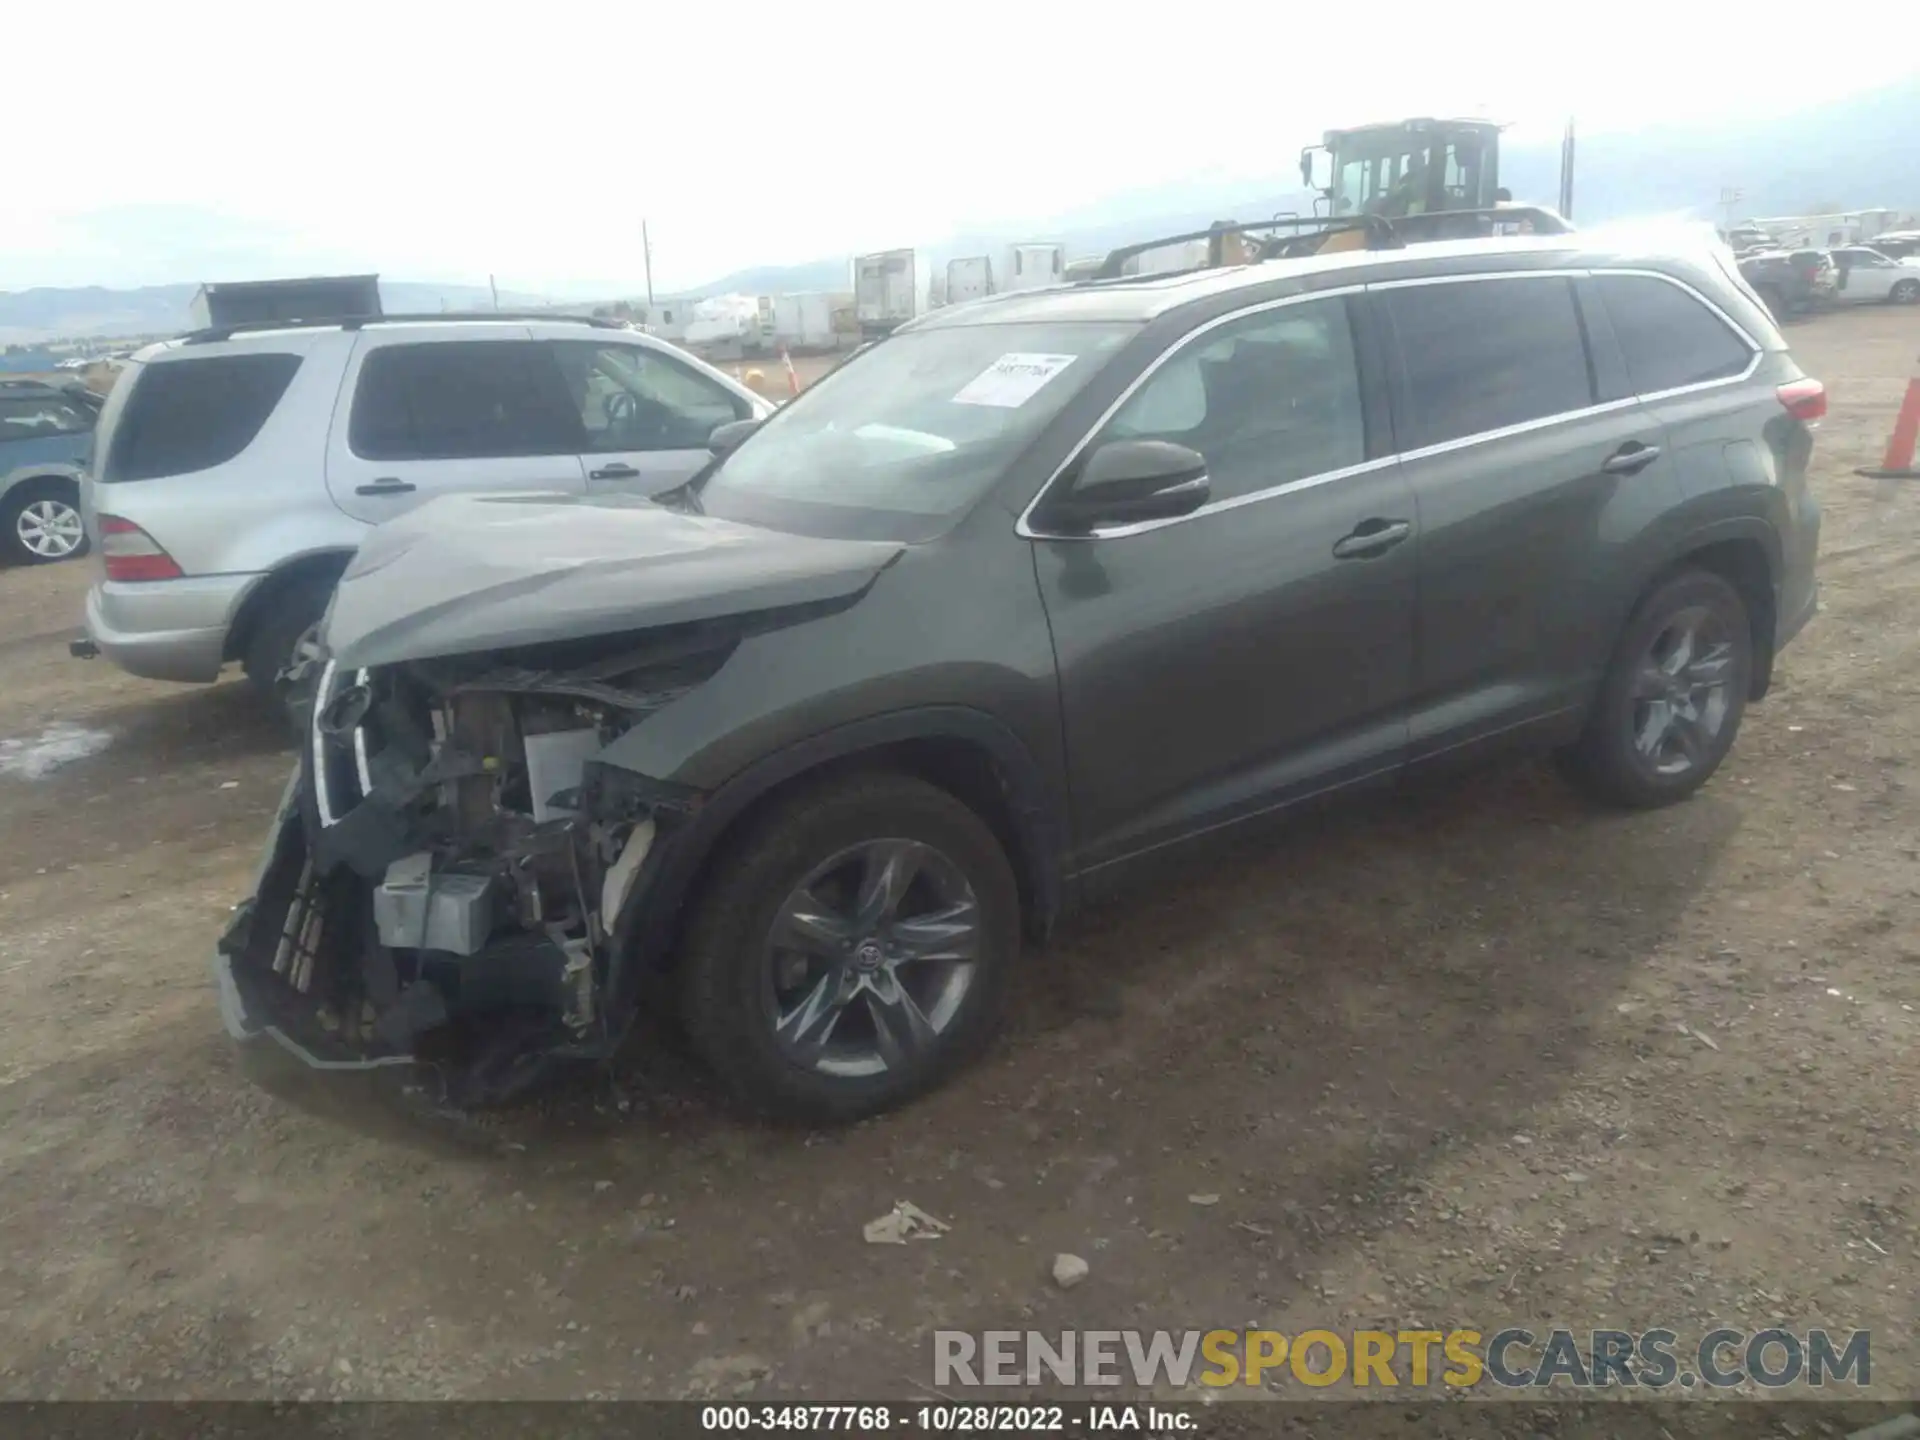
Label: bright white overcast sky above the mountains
xmin=0 ymin=0 xmax=1920 ymax=292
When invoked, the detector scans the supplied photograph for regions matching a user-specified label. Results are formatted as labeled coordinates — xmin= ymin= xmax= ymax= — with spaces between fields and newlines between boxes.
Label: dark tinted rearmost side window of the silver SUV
xmin=100 ymin=353 xmax=300 ymax=484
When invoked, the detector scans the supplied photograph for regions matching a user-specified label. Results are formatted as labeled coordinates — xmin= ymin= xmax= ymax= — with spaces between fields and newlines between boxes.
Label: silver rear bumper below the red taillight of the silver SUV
xmin=86 ymin=574 xmax=263 ymax=684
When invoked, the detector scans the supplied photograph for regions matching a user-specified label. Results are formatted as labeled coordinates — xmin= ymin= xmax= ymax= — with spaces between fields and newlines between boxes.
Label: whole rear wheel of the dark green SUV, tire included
xmin=1559 ymin=570 xmax=1753 ymax=810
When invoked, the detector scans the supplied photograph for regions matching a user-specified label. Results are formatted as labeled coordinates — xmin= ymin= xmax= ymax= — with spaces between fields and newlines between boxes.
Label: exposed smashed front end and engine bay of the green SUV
xmin=221 ymin=622 xmax=741 ymax=1104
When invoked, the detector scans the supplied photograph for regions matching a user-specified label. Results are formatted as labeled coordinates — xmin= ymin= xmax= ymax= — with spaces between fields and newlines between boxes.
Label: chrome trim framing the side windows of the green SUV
xmin=1014 ymin=265 xmax=1766 ymax=541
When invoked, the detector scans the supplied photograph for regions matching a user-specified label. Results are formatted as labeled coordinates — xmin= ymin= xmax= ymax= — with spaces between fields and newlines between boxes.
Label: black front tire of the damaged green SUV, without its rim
xmin=680 ymin=772 xmax=1021 ymax=1121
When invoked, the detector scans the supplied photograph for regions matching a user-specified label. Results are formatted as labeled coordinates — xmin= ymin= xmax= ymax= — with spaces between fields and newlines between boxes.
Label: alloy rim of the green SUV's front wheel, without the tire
xmin=764 ymin=839 xmax=981 ymax=1079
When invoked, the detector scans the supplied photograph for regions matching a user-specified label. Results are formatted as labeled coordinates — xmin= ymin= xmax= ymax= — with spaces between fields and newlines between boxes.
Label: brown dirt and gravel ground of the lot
xmin=0 ymin=301 xmax=1920 ymax=1428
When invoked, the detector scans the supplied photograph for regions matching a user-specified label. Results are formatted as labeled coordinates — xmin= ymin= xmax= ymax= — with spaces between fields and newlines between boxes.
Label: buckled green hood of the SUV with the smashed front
xmin=323 ymin=495 xmax=904 ymax=666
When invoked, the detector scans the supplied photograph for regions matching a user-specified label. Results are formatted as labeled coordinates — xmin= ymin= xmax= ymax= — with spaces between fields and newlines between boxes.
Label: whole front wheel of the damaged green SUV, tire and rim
xmin=680 ymin=772 xmax=1020 ymax=1121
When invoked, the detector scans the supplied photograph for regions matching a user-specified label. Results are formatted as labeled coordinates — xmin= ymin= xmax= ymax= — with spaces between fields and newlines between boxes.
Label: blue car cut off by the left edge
xmin=0 ymin=380 xmax=102 ymax=564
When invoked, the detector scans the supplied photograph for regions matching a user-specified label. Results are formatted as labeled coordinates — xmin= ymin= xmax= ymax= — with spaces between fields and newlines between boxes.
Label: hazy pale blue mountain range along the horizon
xmin=15 ymin=83 xmax=1920 ymax=346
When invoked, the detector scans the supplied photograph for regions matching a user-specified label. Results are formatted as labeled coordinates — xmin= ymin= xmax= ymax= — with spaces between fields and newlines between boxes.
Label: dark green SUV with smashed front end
xmin=217 ymin=221 xmax=1826 ymax=1117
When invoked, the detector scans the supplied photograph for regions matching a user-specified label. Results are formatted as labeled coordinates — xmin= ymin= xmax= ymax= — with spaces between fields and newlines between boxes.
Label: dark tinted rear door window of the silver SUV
xmin=348 ymin=340 xmax=584 ymax=461
